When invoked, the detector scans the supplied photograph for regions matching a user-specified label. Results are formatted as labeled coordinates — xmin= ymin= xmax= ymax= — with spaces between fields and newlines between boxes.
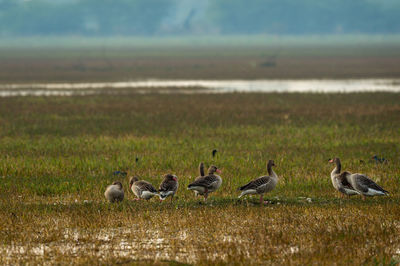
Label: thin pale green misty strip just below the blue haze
xmin=0 ymin=34 xmax=400 ymax=49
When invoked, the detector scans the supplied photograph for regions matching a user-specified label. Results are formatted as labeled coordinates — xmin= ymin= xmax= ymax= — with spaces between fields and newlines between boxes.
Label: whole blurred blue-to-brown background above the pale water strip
xmin=0 ymin=0 xmax=400 ymax=84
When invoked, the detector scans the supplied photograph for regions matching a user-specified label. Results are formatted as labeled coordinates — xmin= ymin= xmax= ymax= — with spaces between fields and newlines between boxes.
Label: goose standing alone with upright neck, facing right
xmin=239 ymin=160 xmax=278 ymax=204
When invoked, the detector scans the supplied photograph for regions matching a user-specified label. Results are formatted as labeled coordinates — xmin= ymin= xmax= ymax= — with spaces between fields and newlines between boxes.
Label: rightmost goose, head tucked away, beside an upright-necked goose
xmin=335 ymin=158 xmax=389 ymax=199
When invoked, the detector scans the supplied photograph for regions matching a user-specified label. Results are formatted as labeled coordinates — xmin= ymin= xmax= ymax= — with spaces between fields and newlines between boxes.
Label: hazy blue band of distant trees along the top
xmin=0 ymin=0 xmax=400 ymax=38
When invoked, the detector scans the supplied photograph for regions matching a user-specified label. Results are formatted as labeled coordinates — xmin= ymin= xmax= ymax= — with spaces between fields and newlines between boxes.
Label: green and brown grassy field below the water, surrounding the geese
xmin=0 ymin=93 xmax=400 ymax=265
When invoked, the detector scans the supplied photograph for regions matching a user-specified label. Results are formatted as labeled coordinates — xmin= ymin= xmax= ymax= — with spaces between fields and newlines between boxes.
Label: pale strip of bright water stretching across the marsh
xmin=0 ymin=79 xmax=400 ymax=97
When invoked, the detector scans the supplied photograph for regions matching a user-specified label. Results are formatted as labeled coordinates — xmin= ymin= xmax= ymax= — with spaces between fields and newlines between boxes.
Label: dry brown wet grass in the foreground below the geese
xmin=2 ymin=200 xmax=400 ymax=264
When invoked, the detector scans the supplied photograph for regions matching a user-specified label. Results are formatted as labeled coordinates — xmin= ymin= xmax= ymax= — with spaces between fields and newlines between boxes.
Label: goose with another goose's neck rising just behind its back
xmin=188 ymin=165 xmax=222 ymax=201
